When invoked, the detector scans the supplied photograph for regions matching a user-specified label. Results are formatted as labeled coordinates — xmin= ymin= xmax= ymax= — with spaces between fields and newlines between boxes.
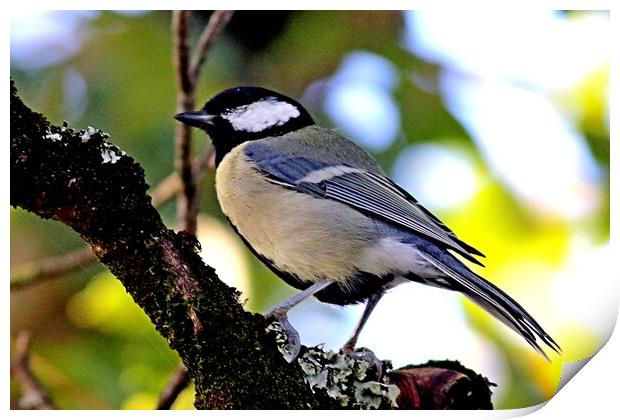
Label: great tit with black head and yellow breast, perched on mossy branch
xmin=175 ymin=87 xmax=560 ymax=357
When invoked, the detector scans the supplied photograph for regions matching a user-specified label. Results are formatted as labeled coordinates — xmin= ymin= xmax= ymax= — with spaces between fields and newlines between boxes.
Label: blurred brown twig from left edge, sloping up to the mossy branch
xmin=11 ymin=248 xmax=97 ymax=290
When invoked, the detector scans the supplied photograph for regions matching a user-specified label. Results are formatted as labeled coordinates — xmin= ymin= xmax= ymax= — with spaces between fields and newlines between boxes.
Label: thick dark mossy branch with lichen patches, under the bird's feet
xmin=11 ymin=82 xmax=490 ymax=409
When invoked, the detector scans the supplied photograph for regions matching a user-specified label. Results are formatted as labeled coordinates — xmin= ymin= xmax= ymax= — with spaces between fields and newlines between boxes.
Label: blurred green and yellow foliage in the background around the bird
xmin=11 ymin=11 xmax=609 ymax=409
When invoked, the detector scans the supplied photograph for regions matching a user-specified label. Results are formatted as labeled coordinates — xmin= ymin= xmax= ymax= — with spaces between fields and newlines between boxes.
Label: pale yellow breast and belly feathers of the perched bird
xmin=216 ymin=143 xmax=372 ymax=281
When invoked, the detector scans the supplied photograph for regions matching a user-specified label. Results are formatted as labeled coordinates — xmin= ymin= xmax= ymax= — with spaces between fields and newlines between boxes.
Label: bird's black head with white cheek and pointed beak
xmin=175 ymin=86 xmax=314 ymax=163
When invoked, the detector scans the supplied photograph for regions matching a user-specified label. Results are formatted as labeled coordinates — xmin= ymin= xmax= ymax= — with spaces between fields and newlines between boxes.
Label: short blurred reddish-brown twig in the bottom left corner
xmin=11 ymin=331 xmax=55 ymax=410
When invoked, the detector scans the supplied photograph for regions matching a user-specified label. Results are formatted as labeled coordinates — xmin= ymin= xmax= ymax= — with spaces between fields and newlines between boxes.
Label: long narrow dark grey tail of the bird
xmin=422 ymin=253 xmax=561 ymax=360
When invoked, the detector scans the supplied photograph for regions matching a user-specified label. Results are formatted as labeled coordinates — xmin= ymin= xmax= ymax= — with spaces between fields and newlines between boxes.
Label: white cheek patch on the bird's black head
xmin=222 ymin=98 xmax=300 ymax=133
